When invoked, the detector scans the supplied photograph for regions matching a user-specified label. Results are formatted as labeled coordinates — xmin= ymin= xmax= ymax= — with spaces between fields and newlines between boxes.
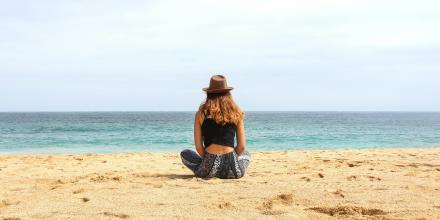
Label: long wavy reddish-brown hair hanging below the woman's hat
xmin=199 ymin=92 xmax=244 ymax=125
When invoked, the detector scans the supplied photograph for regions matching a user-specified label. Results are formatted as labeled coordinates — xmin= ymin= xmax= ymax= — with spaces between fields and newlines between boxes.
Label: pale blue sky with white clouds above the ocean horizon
xmin=0 ymin=0 xmax=440 ymax=111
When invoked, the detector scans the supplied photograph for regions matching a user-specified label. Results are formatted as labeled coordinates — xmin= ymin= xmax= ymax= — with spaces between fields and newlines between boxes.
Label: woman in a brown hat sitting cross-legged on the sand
xmin=180 ymin=75 xmax=250 ymax=179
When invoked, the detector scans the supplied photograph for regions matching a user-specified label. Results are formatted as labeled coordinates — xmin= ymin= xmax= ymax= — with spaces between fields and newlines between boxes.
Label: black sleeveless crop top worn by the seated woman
xmin=202 ymin=112 xmax=237 ymax=147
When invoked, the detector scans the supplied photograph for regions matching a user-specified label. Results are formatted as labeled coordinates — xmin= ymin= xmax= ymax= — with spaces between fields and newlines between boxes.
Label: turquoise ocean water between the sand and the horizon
xmin=0 ymin=112 xmax=440 ymax=153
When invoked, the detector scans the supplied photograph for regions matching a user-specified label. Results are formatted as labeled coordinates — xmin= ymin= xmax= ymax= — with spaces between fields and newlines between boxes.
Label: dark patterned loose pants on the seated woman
xmin=180 ymin=150 xmax=251 ymax=179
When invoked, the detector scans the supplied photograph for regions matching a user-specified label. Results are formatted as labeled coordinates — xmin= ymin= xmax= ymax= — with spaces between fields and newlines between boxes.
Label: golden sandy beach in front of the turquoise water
xmin=0 ymin=148 xmax=440 ymax=219
